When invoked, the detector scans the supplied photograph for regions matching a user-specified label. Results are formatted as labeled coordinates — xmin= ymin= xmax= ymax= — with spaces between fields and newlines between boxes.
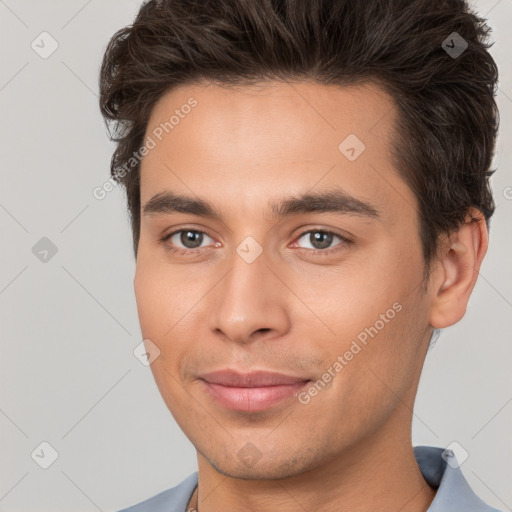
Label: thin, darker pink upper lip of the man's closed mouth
xmin=199 ymin=369 xmax=310 ymax=388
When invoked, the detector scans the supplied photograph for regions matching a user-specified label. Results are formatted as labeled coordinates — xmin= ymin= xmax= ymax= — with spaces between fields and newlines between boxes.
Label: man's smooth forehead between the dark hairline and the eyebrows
xmin=141 ymin=82 xmax=414 ymax=222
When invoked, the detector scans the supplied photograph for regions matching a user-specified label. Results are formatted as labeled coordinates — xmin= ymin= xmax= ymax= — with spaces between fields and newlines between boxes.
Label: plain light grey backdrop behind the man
xmin=0 ymin=0 xmax=512 ymax=512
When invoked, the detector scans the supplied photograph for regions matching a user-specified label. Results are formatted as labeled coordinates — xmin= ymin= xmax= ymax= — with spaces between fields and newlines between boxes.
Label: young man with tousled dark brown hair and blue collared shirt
xmin=100 ymin=0 xmax=498 ymax=512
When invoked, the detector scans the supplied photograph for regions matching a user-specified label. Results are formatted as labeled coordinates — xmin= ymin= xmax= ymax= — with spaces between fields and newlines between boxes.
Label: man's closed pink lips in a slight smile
xmin=200 ymin=370 xmax=311 ymax=412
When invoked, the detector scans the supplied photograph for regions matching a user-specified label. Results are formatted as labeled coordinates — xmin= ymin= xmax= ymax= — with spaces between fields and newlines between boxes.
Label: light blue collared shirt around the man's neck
xmin=119 ymin=446 xmax=500 ymax=512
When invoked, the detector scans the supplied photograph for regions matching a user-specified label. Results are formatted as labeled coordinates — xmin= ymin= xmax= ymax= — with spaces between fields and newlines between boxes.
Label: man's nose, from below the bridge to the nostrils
xmin=210 ymin=247 xmax=290 ymax=344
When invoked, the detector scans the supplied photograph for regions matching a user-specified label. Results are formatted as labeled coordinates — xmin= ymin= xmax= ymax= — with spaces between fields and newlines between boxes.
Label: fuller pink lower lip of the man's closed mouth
xmin=202 ymin=381 xmax=310 ymax=412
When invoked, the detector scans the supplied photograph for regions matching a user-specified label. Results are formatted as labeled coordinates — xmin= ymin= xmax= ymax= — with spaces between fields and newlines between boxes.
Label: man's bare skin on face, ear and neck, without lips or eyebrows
xmin=134 ymin=82 xmax=488 ymax=512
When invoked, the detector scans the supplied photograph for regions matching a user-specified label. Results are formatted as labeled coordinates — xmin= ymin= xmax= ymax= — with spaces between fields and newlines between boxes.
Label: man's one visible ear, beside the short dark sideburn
xmin=429 ymin=208 xmax=489 ymax=329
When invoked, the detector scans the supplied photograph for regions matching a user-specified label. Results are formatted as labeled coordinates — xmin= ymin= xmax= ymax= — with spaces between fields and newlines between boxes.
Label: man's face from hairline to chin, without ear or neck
xmin=134 ymin=83 xmax=431 ymax=479
